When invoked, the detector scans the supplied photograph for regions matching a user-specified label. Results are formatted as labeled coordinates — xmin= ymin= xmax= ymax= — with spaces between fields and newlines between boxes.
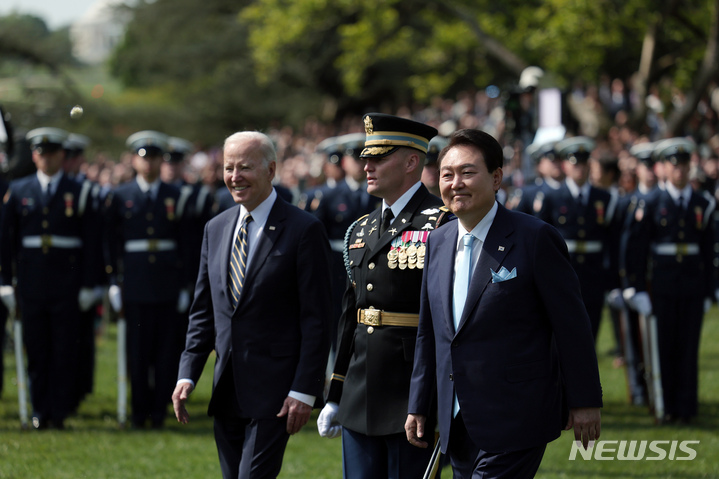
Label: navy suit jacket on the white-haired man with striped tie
xmin=178 ymin=197 xmax=330 ymax=418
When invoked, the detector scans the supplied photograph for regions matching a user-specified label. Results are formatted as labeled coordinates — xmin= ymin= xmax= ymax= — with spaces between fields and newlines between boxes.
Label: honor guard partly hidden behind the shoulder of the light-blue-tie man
xmin=539 ymin=136 xmax=618 ymax=340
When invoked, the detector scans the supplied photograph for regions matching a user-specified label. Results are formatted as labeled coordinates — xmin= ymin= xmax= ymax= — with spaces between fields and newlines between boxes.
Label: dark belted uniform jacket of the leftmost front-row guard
xmin=0 ymin=175 xmax=100 ymax=301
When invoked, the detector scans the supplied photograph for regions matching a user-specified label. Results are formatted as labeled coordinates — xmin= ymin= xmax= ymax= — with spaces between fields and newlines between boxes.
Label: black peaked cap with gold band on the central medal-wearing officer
xmin=360 ymin=113 xmax=437 ymax=158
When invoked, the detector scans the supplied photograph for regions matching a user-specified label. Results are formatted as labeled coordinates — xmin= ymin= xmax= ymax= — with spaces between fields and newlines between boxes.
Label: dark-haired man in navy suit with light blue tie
xmin=405 ymin=130 xmax=602 ymax=478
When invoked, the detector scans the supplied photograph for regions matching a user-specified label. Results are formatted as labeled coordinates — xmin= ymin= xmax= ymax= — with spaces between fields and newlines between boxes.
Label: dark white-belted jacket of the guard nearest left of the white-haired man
xmin=105 ymin=181 xmax=194 ymax=303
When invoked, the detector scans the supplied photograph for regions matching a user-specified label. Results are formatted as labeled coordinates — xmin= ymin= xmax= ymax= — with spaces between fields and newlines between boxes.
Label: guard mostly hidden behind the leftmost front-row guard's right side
xmin=62 ymin=133 xmax=106 ymax=407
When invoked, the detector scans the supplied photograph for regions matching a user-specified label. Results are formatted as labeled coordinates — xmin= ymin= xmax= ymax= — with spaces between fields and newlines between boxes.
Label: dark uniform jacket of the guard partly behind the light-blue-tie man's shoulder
xmin=539 ymin=183 xmax=619 ymax=308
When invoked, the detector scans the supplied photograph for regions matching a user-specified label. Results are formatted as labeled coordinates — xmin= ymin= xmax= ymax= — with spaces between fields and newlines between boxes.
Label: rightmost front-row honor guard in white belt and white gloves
xmin=624 ymin=138 xmax=716 ymax=423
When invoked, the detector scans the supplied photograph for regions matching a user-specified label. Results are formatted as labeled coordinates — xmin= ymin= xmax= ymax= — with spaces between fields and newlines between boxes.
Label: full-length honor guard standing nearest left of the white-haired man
xmin=105 ymin=131 xmax=192 ymax=428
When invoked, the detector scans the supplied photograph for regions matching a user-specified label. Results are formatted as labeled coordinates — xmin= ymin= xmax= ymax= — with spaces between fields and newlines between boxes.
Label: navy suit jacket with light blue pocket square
xmin=408 ymin=205 xmax=602 ymax=452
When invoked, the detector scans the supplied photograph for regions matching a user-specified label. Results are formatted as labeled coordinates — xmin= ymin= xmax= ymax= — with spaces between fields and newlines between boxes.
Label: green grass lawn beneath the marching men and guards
xmin=0 ymin=307 xmax=719 ymax=479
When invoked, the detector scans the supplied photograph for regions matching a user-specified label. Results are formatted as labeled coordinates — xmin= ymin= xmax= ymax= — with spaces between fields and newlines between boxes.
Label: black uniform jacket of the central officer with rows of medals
xmin=327 ymin=186 xmax=450 ymax=436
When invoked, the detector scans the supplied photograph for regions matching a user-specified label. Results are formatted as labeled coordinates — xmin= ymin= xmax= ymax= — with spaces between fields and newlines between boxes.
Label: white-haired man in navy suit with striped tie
xmin=172 ymin=132 xmax=331 ymax=479
